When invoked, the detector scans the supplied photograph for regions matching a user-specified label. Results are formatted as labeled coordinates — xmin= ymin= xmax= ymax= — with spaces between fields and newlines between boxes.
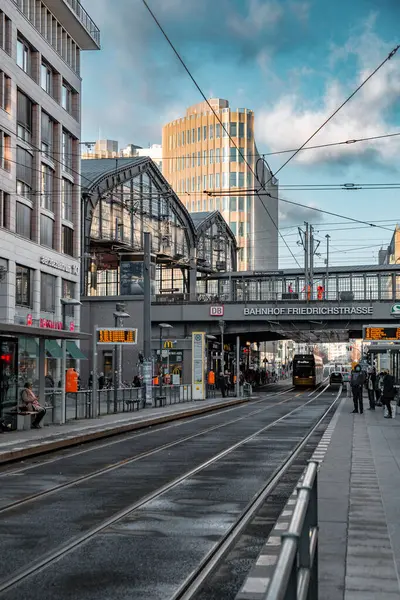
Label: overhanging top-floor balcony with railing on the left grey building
xmin=43 ymin=0 xmax=100 ymax=50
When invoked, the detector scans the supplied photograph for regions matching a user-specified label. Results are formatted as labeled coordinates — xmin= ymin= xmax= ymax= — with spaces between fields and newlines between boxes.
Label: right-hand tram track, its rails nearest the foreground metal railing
xmin=0 ymin=386 xmax=340 ymax=598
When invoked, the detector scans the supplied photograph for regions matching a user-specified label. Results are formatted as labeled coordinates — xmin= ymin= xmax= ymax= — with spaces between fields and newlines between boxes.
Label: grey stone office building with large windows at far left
xmin=0 ymin=0 xmax=100 ymax=414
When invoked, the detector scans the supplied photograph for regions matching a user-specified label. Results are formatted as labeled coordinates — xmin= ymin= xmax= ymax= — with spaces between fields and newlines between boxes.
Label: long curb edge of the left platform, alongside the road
xmin=0 ymin=397 xmax=254 ymax=464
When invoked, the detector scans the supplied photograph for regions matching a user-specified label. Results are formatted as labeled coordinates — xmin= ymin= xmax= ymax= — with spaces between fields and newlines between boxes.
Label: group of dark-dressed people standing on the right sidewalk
xmin=350 ymin=365 xmax=396 ymax=419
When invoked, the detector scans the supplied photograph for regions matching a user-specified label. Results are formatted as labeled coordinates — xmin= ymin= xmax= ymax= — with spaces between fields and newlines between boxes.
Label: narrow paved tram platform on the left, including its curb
xmin=0 ymin=396 xmax=254 ymax=464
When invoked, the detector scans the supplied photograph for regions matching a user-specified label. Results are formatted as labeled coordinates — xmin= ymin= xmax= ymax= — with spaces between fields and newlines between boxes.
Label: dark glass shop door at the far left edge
xmin=0 ymin=338 xmax=18 ymax=417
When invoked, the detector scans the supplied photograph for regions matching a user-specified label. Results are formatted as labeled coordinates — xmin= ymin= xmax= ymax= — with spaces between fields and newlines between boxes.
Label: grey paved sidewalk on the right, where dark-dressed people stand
xmin=318 ymin=399 xmax=400 ymax=600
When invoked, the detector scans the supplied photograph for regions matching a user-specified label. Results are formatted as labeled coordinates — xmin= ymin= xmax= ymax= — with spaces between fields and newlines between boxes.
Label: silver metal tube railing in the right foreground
xmin=264 ymin=462 xmax=318 ymax=600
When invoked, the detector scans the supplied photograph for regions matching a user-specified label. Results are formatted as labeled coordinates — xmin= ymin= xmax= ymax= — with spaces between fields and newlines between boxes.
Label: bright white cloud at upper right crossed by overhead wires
xmin=257 ymin=19 xmax=400 ymax=164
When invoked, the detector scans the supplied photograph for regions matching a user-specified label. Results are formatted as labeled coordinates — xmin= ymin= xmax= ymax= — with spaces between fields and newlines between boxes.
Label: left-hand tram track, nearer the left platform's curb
xmin=0 ymin=389 xmax=302 ymax=515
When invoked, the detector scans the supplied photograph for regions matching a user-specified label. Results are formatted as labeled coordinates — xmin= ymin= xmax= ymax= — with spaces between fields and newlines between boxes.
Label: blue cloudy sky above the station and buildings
xmin=81 ymin=0 xmax=400 ymax=268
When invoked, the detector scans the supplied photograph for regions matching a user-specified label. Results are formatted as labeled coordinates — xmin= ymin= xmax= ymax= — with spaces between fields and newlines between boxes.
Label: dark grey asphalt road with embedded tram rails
xmin=0 ymin=384 xmax=340 ymax=600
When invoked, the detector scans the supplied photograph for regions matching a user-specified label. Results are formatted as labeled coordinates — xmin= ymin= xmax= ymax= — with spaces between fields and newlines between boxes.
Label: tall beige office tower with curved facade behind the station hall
xmin=162 ymin=98 xmax=278 ymax=271
